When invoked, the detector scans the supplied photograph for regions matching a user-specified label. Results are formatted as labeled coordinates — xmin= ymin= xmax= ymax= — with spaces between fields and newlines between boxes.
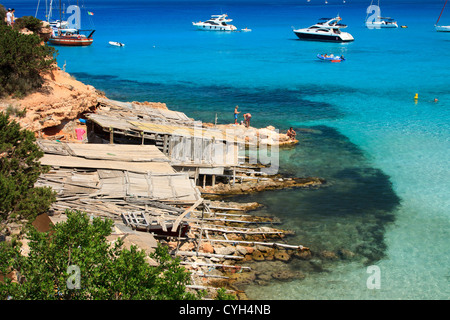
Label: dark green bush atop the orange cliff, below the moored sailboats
xmin=0 ymin=24 xmax=56 ymax=97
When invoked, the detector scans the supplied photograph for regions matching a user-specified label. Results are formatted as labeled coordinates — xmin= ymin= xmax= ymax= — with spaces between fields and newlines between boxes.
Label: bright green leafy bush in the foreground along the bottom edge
xmin=0 ymin=211 xmax=198 ymax=300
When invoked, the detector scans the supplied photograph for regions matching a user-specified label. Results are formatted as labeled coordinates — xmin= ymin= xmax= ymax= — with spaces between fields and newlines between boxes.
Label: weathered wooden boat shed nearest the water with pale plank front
xmin=86 ymin=99 xmax=245 ymax=185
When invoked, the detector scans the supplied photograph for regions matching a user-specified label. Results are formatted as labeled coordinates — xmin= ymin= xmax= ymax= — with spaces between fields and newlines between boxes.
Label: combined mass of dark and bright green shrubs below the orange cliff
xmin=0 ymin=115 xmax=233 ymax=300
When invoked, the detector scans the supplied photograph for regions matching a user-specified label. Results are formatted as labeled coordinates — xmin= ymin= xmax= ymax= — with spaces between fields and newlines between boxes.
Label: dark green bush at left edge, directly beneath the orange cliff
xmin=0 ymin=113 xmax=55 ymax=221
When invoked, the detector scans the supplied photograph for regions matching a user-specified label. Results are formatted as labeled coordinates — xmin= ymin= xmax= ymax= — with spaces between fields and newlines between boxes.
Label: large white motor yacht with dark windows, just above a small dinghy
xmin=294 ymin=17 xmax=355 ymax=42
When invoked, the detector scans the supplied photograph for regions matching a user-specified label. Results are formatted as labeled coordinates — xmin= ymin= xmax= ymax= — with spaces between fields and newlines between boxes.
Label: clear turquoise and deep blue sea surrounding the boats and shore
xmin=2 ymin=0 xmax=450 ymax=300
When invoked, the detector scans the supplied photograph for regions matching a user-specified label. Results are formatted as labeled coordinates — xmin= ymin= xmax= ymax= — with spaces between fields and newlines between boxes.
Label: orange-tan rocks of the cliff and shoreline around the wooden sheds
xmin=0 ymin=69 xmax=334 ymax=299
